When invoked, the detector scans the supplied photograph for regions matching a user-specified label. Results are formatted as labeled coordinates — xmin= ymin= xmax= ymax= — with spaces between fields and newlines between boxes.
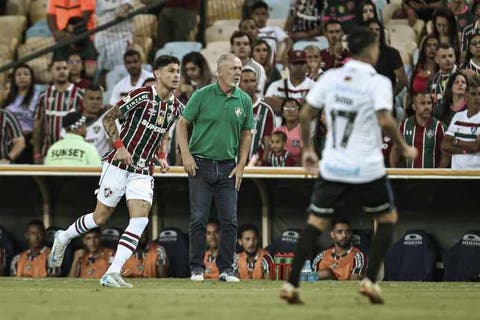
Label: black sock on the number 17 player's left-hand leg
xmin=288 ymin=225 xmax=322 ymax=287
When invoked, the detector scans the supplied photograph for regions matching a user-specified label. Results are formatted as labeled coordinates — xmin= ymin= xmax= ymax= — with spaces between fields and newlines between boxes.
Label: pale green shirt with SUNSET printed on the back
xmin=45 ymin=133 xmax=102 ymax=167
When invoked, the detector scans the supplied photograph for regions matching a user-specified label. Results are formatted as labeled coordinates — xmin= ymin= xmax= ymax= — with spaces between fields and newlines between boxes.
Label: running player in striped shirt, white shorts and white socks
xmin=49 ymin=55 xmax=184 ymax=287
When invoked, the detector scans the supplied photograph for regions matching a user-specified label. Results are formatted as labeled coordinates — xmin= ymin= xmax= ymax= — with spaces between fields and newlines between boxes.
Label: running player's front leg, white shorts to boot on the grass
xmin=100 ymin=173 xmax=153 ymax=287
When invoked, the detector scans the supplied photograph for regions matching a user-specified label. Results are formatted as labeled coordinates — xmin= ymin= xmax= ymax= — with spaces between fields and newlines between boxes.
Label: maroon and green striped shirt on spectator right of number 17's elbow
xmin=400 ymin=116 xmax=445 ymax=168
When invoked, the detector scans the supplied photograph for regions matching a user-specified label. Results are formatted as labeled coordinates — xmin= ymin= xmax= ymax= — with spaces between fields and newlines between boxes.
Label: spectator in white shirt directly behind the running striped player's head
xmin=109 ymin=49 xmax=153 ymax=104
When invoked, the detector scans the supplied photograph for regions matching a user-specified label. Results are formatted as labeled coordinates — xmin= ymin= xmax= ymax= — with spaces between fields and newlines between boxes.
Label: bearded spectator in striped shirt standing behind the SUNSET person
xmin=33 ymin=57 xmax=83 ymax=164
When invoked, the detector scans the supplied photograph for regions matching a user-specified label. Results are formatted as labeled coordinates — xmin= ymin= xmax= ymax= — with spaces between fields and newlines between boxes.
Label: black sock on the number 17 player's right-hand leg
xmin=367 ymin=223 xmax=394 ymax=282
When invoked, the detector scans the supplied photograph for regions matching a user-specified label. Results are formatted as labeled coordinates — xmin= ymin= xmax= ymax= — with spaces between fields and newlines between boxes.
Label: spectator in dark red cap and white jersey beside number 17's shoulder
xmin=265 ymin=50 xmax=315 ymax=119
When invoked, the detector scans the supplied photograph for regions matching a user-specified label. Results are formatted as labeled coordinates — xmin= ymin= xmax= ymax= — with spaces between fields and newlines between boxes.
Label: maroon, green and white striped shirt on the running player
xmin=104 ymin=86 xmax=185 ymax=175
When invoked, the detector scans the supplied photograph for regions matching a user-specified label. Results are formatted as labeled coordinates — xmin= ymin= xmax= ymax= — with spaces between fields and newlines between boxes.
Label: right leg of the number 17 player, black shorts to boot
xmin=360 ymin=176 xmax=398 ymax=303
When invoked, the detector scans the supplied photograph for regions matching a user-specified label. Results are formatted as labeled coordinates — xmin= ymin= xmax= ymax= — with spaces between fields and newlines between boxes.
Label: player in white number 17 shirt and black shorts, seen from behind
xmin=280 ymin=28 xmax=417 ymax=303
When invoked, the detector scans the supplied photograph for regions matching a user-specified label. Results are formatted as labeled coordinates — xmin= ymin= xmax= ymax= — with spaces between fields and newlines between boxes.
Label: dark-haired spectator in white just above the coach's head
xmin=230 ymin=31 xmax=267 ymax=97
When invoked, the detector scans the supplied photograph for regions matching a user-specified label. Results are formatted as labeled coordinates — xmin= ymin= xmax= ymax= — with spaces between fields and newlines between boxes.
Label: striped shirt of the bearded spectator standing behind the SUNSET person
xmin=35 ymin=84 xmax=83 ymax=156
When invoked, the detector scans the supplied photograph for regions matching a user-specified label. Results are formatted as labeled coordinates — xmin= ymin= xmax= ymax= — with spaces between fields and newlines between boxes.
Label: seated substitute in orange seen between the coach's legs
xmin=203 ymin=218 xmax=220 ymax=280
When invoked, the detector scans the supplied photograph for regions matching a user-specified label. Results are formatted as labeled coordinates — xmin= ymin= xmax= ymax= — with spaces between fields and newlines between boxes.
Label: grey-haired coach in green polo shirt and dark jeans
xmin=177 ymin=54 xmax=253 ymax=282
